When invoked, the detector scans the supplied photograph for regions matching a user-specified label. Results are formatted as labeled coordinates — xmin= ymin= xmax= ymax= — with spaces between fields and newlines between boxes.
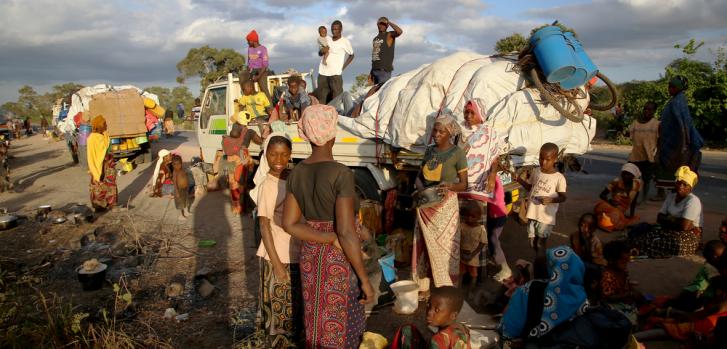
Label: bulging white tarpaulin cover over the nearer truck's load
xmin=339 ymin=52 xmax=596 ymax=164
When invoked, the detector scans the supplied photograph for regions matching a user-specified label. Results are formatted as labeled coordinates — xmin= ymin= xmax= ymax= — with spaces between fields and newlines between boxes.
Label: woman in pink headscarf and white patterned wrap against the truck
xmin=459 ymin=98 xmax=512 ymax=281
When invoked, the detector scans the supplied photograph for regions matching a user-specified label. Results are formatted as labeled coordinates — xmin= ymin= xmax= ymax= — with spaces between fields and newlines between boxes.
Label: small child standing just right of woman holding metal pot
xmin=459 ymin=200 xmax=487 ymax=280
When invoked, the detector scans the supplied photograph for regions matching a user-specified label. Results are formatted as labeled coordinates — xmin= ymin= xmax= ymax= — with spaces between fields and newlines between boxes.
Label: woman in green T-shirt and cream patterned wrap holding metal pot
xmin=412 ymin=114 xmax=467 ymax=287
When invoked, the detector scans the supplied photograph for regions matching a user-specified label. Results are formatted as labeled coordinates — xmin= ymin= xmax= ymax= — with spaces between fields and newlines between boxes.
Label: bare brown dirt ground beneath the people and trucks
xmin=0 ymin=132 xmax=725 ymax=348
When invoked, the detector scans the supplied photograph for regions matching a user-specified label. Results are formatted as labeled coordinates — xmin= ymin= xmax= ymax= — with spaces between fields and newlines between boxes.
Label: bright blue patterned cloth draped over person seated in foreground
xmin=500 ymin=246 xmax=588 ymax=338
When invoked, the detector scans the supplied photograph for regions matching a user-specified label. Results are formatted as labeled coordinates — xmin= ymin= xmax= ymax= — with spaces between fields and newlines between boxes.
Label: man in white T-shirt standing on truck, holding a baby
xmin=316 ymin=20 xmax=353 ymax=104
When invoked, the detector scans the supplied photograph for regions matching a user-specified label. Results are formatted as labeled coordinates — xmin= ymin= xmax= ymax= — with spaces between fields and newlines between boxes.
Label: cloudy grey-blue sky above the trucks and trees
xmin=0 ymin=0 xmax=727 ymax=104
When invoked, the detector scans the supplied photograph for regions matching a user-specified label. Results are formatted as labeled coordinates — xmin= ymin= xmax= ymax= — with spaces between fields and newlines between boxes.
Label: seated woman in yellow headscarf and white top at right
xmin=629 ymin=166 xmax=704 ymax=258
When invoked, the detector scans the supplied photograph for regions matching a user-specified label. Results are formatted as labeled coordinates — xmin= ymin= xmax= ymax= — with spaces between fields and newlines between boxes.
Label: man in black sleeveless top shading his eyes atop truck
xmin=371 ymin=17 xmax=404 ymax=85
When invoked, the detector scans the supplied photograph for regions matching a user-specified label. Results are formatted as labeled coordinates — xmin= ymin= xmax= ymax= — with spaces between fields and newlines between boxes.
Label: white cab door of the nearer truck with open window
xmin=197 ymin=86 xmax=228 ymax=163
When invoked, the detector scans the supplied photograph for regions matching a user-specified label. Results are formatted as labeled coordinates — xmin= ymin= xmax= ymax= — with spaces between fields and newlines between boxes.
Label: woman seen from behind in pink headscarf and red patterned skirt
xmin=283 ymin=105 xmax=374 ymax=348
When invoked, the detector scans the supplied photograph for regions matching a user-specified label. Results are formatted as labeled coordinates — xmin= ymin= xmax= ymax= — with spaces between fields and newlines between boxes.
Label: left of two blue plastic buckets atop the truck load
xmin=530 ymin=26 xmax=576 ymax=83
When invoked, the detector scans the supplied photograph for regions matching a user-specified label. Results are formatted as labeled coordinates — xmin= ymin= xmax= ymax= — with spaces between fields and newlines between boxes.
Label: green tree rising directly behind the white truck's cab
xmin=177 ymin=45 xmax=245 ymax=91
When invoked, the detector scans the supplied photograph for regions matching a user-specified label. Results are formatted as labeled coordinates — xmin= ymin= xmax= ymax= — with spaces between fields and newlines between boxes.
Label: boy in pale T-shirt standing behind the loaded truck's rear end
xmin=517 ymin=143 xmax=566 ymax=255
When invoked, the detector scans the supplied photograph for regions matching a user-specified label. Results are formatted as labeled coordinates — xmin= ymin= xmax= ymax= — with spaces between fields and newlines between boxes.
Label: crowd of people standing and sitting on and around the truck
xmin=58 ymin=17 xmax=727 ymax=348
